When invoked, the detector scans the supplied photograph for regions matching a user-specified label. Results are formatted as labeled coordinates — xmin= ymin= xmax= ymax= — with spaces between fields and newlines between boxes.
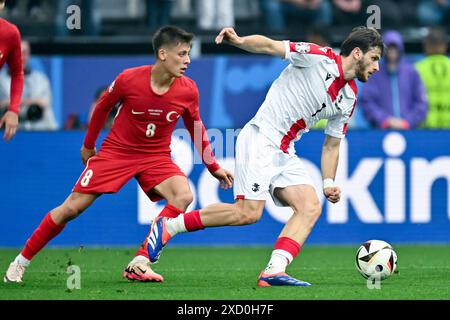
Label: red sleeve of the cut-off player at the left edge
xmin=7 ymin=27 xmax=24 ymax=113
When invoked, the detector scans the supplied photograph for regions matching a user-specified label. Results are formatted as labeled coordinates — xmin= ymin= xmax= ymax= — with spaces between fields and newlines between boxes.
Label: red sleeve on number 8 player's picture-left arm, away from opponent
xmin=84 ymin=73 xmax=124 ymax=149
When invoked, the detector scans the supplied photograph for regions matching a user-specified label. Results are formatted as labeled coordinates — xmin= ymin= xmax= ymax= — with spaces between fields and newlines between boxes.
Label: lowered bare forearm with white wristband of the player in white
xmin=321 ymin=135 xmax=341 ymax=203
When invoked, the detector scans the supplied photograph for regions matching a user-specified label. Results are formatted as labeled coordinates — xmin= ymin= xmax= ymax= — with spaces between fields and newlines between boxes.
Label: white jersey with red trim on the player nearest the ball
xmin=250 ymin=41 xmax=357 ymax=153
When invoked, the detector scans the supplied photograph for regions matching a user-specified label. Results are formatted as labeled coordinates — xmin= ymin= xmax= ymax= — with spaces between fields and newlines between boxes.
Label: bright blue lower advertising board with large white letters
xmin=0 ymin=129 xmax=450 ymax=247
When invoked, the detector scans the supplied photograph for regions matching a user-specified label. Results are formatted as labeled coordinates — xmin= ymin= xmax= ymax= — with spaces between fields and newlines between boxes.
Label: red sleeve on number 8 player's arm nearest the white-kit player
xmin=183 ymin=85 xmax=220 ymax=172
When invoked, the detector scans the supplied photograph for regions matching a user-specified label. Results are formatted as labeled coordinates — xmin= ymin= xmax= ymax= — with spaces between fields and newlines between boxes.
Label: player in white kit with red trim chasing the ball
xmin=148 ymin=27 xmax=384 ymax=286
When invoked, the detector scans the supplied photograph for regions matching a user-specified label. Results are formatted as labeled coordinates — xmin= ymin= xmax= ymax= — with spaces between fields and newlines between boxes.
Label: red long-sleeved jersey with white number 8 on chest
xmin=84 ymin=66 xmax=220 ymax=172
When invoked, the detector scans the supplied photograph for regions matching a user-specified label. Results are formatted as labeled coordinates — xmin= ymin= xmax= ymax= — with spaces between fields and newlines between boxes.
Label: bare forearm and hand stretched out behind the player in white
xmin=216 ymin=28 xmax=286 ymax=58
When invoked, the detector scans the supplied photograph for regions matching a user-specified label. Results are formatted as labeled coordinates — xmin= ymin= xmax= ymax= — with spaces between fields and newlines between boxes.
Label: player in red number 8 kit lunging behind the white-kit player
xmin=4 ymin=26 xmax=233 ymax=282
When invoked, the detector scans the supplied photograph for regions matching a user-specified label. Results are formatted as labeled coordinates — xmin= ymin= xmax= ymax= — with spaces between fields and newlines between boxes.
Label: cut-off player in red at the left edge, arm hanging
xmin=0 ymin=0 xmax=23 ymax=141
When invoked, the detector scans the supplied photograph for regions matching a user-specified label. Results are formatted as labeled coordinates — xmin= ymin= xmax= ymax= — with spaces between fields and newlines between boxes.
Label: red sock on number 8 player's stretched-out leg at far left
xmin=21 ymin=212 xmax=65 ymax=260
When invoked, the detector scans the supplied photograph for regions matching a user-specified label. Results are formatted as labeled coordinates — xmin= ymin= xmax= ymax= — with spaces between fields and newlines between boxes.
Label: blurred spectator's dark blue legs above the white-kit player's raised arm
xmin=259 ymin=0 xmax=333 ymax=32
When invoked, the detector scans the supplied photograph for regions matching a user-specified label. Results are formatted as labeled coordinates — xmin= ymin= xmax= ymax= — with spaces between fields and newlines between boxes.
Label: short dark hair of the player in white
xmin=341 ymin=27 xmax=384 ymax=57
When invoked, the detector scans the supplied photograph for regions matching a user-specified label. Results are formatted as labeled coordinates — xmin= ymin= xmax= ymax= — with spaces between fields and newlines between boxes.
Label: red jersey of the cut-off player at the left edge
xmin=0 ymin=18 xmax=23 ymax=113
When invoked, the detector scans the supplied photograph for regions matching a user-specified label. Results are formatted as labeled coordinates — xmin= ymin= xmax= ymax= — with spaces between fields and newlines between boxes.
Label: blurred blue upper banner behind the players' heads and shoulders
xmin=21 ymin=55 xmax=428 ymax=129
